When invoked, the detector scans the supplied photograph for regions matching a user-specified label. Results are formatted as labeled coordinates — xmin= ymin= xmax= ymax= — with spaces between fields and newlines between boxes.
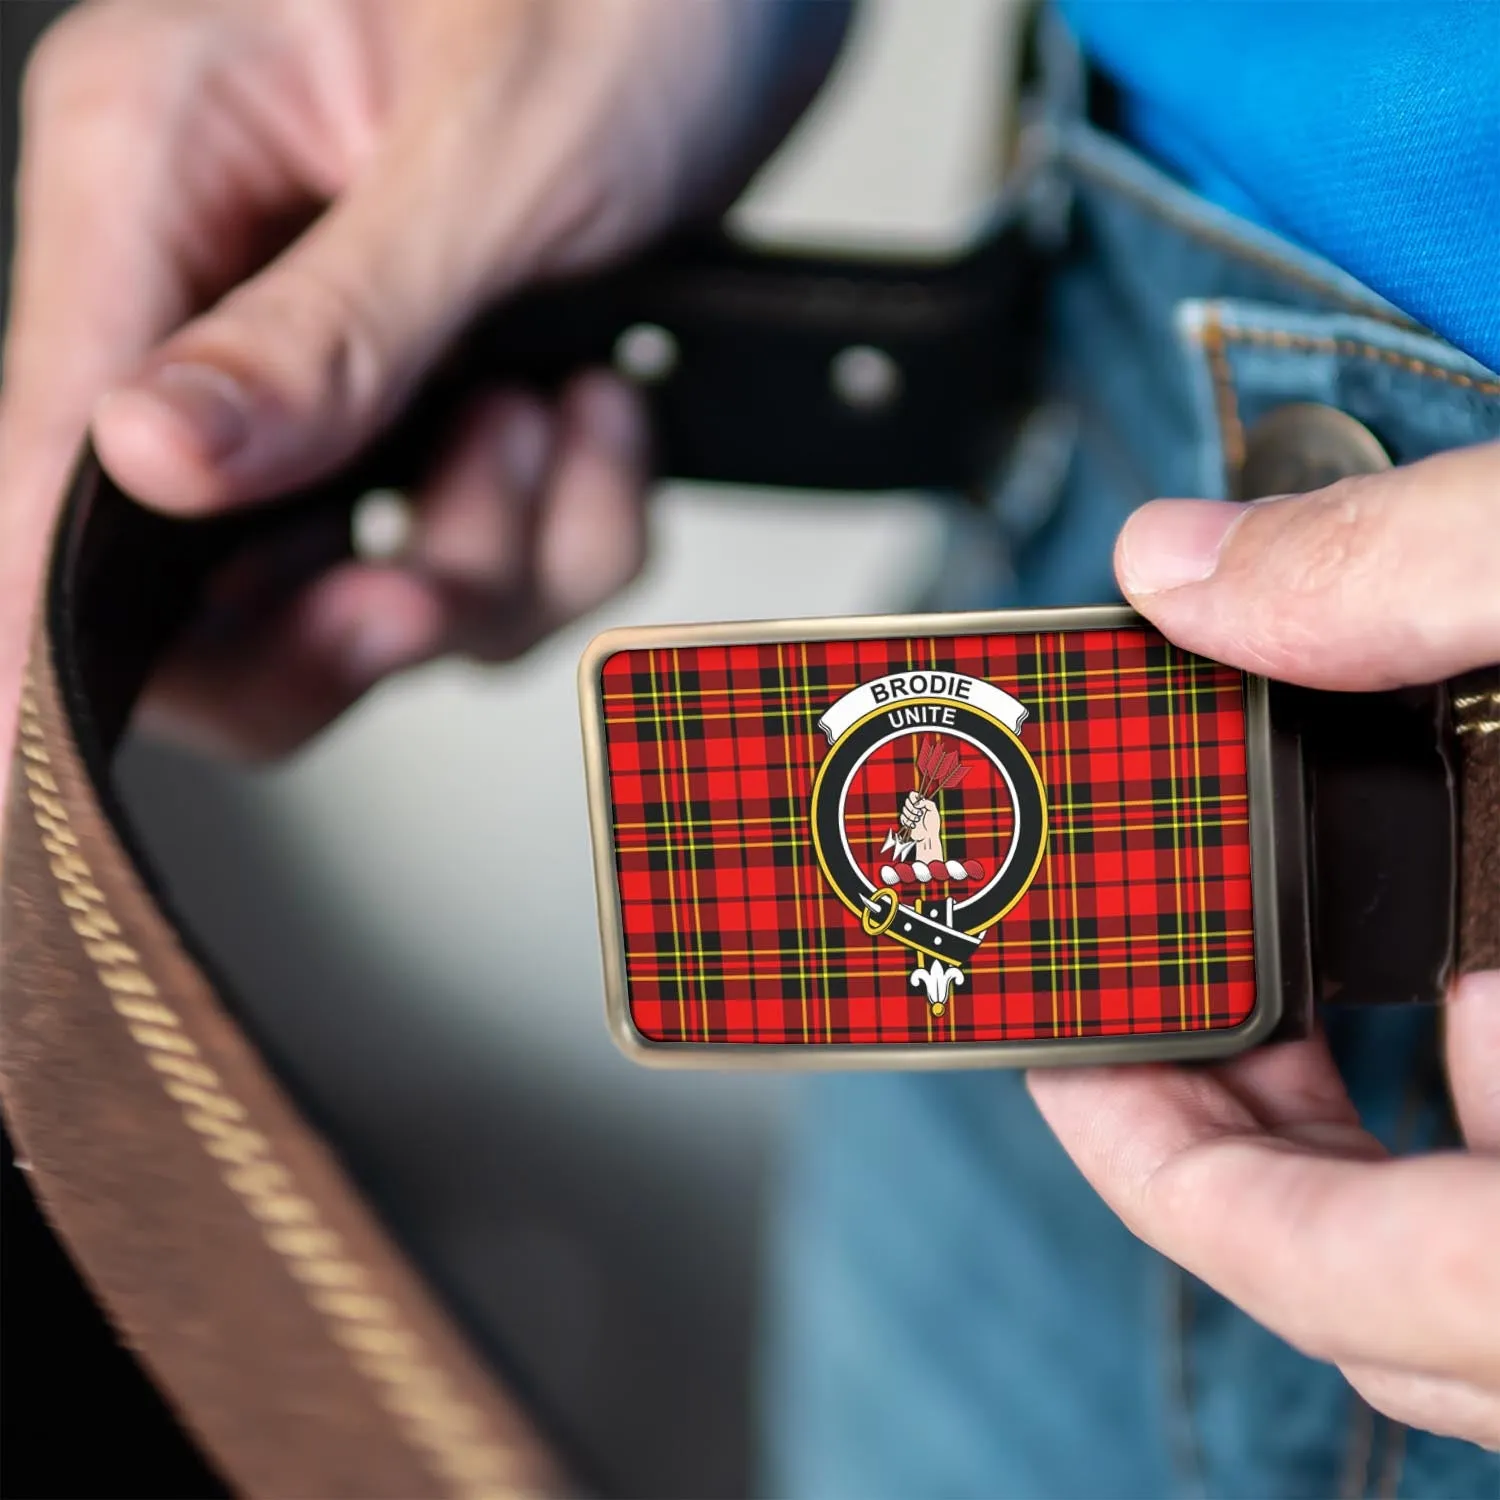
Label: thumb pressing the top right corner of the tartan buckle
xmin=1115 ymin=444 xmax=1500 ymax=690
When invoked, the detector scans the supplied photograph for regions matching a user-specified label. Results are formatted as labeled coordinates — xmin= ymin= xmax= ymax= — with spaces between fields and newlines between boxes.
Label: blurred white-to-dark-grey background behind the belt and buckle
xmin=123 ymin=0 xmax=1014 ymax=1496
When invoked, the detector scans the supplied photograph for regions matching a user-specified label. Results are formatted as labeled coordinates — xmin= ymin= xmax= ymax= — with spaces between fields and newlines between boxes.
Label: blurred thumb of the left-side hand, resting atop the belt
xmin=93 ymin=141 xmax=516 ymax=513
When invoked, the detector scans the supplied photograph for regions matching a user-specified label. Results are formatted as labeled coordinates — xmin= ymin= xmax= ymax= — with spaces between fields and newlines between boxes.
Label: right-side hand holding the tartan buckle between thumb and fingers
xmin=1031 ymin=447 xmax=1500 ymax=1448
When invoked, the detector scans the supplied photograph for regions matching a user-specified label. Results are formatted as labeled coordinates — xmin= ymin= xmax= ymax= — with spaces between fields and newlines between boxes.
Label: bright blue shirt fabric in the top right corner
xmin=1062 ymin=0 xmax=1500 ymax=369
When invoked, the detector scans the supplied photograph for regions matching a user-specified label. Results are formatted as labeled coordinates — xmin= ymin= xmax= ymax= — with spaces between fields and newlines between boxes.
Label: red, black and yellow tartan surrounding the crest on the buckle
xmin=602 ymin=627 xmax=1256 ymax=1046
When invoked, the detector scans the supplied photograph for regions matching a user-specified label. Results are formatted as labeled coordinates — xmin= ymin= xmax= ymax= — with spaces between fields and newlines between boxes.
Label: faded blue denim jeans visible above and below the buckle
xmin=762 ymin=102 xmax=1500 ymax=1500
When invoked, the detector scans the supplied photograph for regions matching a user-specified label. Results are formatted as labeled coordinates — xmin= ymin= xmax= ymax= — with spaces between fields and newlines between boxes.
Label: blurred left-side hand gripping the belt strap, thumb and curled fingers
xmin=0 ymin=0 xmax=840 ymax=753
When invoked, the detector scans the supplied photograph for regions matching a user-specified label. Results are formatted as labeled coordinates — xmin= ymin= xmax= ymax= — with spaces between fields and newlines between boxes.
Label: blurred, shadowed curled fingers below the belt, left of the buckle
xmin=140 ymin=377 xmax=644 ymax=759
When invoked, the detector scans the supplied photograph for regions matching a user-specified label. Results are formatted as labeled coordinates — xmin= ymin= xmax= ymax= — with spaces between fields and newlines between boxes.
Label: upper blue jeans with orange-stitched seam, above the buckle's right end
xmin=950 ymin=87 xmax=1500 ymax=608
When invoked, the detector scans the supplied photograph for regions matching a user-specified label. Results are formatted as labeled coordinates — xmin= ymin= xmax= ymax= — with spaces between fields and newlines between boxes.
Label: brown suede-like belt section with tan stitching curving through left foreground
xmin=0 ymin=464 xmax=570 ymax=1497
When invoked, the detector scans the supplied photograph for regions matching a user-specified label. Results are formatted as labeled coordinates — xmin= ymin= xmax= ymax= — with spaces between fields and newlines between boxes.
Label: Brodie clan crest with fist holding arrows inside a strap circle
xmin=812 ymin=671 xmax=1047 ymax=1016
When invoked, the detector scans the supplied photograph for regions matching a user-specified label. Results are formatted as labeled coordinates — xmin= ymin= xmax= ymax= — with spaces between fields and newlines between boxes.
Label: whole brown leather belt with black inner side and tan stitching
xmin=0 ymin=228 xmax=1500 ymax=1497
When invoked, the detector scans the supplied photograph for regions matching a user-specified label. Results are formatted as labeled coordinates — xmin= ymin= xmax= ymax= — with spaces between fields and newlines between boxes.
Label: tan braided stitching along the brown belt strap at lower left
xmin=20 ymin=674 xmax=534 ymax=1500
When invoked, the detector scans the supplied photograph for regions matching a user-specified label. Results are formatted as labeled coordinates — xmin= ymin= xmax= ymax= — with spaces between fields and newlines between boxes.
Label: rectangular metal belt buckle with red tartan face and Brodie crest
xmin=579 ymin=608 xmax=1452 ymax=1068
